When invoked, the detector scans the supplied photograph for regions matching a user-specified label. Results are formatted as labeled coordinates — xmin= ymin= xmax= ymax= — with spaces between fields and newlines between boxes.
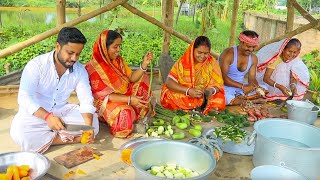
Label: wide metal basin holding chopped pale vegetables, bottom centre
xmin=131 ymin=140 xmax=216 ymax=180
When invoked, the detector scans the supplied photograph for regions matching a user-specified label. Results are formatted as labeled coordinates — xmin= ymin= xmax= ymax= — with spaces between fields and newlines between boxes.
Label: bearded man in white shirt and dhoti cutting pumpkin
xmin=10 ymin=27 xmax=99 ymax=153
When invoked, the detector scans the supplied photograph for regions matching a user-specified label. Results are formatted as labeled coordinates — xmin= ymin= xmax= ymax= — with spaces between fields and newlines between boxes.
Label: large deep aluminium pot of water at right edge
xmin=253 ymin=118 xmax=320 ymax=179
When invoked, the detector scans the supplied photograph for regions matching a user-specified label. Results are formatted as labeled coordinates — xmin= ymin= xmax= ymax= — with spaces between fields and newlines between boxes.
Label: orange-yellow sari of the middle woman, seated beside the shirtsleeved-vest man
xmin=160 ymin=38 xmax=225 ymax=113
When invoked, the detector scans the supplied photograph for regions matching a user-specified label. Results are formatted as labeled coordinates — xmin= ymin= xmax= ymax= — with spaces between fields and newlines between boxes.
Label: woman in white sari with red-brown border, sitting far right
xmin=257 ymin=38 xmax=310 ymax=101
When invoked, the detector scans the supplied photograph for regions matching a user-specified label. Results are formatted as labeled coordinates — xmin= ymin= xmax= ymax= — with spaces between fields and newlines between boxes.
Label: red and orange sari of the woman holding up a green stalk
xmin=86 ymin=30 xmax=149 ymax=138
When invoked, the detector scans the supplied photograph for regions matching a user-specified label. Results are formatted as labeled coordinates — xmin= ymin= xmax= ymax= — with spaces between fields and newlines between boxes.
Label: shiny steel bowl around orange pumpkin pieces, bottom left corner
xmin=0 ymin=152 xmax=50 ymax=179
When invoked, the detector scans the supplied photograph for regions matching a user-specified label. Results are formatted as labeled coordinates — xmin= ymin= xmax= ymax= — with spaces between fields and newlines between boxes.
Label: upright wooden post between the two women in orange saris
xmin=162 ymin=0 xmax=174 ymax=54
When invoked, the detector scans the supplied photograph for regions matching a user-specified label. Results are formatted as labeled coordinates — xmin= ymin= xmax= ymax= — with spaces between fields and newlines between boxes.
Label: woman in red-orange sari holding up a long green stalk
xmin=86 ymin=30 xmax=153 ymax=138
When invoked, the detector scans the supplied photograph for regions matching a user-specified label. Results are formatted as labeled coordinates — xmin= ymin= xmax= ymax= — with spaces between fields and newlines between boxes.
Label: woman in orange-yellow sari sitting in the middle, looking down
xmin=160 ymin=36 xmax=226 ymax=114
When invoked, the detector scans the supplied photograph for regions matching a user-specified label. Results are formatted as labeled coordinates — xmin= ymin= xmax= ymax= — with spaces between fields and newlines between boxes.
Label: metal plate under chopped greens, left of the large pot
xmin=206 ymin=128 xmax=255 ymax=155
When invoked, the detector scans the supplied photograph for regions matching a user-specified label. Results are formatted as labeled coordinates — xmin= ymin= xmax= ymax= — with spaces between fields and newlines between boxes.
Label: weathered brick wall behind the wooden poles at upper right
xmin=243 ymin=12 xmax=320 ymax=56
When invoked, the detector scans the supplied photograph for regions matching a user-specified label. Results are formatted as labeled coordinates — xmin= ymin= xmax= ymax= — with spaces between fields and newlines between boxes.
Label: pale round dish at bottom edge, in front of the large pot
xmin=251 ymin=165 xmax=306 ymax=180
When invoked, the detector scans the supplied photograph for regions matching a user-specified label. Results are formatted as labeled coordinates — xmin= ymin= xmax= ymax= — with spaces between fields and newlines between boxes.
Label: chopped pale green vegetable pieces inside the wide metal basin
xmin=147 ymin=164 xmax=199 ymax=179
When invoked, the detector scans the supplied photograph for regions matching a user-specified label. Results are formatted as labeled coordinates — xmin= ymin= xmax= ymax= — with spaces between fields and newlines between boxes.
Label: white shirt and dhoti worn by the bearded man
xmin=10 ymin=51 xmax=99 ymax=152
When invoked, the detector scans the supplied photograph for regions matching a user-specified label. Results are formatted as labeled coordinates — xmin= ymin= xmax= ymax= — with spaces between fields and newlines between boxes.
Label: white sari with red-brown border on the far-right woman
xmin=256 ymin=38 xmax=310 ymax=100
